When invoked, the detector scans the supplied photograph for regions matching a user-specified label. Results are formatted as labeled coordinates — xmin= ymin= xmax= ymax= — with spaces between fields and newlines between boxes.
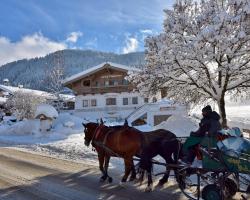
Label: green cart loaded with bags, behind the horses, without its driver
xmin=172 ymin=129 xmax=250 ymax=200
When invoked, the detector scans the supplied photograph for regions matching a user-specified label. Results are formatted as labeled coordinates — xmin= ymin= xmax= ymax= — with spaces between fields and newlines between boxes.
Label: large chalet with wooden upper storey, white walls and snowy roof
xmin=64 ymin=62 xmax=187 ymax=125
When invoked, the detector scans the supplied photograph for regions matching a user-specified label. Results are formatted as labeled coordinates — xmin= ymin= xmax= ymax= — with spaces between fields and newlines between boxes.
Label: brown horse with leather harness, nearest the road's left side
xmin=83 ymin=122 xmax=142 ymax=182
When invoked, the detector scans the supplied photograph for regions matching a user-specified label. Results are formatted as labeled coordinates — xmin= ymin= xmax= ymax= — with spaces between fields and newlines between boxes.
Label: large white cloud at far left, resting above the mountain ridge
xmin=0 ymin=33 xmax=67 ymax=65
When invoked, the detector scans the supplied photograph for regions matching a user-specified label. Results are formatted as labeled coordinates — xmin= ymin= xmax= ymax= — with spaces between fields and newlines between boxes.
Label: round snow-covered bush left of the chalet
xmin=6 ymin=92 xmax=45 ymax=120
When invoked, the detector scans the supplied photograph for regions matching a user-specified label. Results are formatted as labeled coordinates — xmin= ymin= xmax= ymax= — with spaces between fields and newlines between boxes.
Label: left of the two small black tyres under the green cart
xmin=202 ymin=184 xmax=222 ymax=200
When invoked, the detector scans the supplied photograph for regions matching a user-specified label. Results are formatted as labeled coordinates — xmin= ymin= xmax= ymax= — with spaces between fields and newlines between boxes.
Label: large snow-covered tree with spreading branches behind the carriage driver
xmin=129 ymin=0 xmax=250 ymax=126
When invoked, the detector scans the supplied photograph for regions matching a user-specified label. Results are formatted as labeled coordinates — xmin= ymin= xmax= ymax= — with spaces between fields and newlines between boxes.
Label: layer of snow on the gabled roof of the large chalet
xmin=63 ymin=62 xmax=140 ymax=84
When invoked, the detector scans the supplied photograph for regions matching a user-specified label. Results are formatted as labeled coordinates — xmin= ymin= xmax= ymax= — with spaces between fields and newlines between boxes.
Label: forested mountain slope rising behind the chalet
xmin=0 ymin=50 xmax=144 ymax=90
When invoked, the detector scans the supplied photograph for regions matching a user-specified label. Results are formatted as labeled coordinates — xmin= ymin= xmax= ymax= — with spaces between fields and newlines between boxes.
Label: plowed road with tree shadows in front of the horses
xmin=0 ymin=148 xmax=186 ymax=200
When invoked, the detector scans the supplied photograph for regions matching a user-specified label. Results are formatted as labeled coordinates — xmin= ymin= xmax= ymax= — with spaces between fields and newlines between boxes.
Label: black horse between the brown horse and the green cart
xmin=139 ymin=130 xmax=182 ymax=192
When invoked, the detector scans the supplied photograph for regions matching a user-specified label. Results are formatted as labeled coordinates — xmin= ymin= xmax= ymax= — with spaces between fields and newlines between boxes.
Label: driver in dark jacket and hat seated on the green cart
xmin=182 ymin=105 xmax=221 ymax=164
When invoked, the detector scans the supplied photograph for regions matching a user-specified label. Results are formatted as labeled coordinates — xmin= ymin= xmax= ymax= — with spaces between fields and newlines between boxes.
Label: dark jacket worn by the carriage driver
xmin=191 ymin=111 xmax=221 ymax=137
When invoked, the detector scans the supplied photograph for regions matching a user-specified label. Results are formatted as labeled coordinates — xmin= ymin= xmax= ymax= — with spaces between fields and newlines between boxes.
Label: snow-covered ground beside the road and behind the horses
xmin=0 ymin=101 xmax=250 ymax=173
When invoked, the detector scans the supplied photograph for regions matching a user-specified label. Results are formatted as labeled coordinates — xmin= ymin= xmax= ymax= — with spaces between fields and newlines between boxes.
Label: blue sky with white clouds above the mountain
xmin=0 ymin=0 xmax=174 ymax=65
